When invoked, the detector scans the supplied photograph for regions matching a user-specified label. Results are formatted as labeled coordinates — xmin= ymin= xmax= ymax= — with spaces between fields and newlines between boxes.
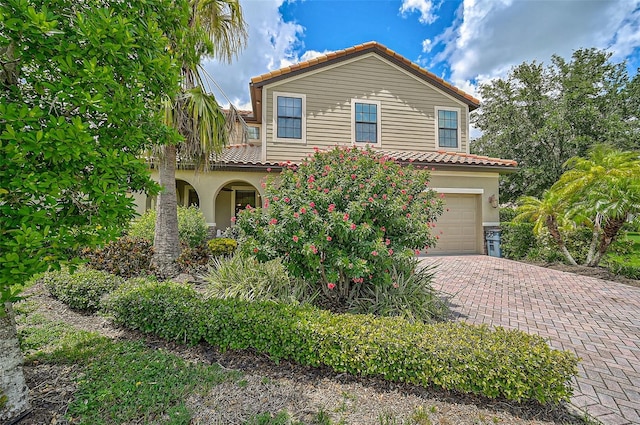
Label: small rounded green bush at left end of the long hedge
xmin=39 ymin=267 xmax=123 ymax=312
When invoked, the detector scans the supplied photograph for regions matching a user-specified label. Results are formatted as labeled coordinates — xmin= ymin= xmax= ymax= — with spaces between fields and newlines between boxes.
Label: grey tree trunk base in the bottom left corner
xmin=0 ymin=303 xmax=29 ymax=423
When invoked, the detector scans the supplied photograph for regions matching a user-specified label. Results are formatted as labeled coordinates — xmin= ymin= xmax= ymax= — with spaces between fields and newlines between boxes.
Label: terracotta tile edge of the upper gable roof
xmin=251 ymin=41 xmax=480 ymax=110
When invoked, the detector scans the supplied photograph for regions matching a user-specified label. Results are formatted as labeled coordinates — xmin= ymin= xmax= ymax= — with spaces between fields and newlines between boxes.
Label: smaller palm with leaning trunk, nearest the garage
xmin=514 ymin=190 xmax=578 ymax=266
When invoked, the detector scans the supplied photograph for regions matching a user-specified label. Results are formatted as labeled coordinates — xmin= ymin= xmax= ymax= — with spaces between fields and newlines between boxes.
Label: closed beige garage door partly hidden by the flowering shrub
xmin=428 ymin=193 xmax=482 ymax=254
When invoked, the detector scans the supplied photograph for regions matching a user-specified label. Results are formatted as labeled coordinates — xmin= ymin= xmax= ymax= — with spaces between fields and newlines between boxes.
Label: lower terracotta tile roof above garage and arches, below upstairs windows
xmin=205 ymin=144 xmax=518 ymax=169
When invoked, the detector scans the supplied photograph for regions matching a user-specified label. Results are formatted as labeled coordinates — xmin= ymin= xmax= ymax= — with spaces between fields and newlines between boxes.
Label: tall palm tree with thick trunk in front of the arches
xmin=154 ymin=0 xmax=247 ymax=275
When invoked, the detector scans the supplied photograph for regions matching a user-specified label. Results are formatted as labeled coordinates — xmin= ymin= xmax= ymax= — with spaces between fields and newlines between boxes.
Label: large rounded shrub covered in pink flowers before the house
xmin=237 ymin=147 xmax=442 ymax=305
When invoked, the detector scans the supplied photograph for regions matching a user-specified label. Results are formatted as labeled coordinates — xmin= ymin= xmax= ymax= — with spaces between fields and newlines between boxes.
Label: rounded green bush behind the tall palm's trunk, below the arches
xmin=127 ymin=206 xmax=209 ymax=248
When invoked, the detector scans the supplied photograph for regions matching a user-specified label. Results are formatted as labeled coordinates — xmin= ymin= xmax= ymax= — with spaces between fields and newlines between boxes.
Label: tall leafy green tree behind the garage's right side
xmin=471 ymin=49 xmax=640 ymax=201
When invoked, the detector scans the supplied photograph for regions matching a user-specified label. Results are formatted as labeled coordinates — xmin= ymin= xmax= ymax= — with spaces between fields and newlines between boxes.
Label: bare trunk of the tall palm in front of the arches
xmin=153 ymin=145 xmax=180 ymax=277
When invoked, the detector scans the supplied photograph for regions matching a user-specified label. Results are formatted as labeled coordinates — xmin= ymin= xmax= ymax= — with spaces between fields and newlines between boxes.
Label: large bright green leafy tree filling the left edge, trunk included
xmin=0 ymin=0 xmax=187 ymax=422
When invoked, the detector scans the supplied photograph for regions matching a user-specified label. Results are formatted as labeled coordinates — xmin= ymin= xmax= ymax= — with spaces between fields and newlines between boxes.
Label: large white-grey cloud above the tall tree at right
xmin=431 ymin=0 xmax=640 ymax=88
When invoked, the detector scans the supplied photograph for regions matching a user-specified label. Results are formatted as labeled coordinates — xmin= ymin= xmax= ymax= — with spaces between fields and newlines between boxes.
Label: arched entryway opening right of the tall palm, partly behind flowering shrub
xmin=214 ymin=180 xmax=262 ymax=232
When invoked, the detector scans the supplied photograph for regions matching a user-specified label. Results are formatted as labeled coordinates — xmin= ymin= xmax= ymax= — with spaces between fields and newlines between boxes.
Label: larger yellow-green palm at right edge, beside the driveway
xmin=551 ymin=145 xmax=640 ymax=267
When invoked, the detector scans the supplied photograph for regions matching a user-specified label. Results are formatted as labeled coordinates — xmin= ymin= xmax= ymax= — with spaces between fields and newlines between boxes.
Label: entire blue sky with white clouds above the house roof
xmin=204 ymin=0 xmax=640 ymax=109
